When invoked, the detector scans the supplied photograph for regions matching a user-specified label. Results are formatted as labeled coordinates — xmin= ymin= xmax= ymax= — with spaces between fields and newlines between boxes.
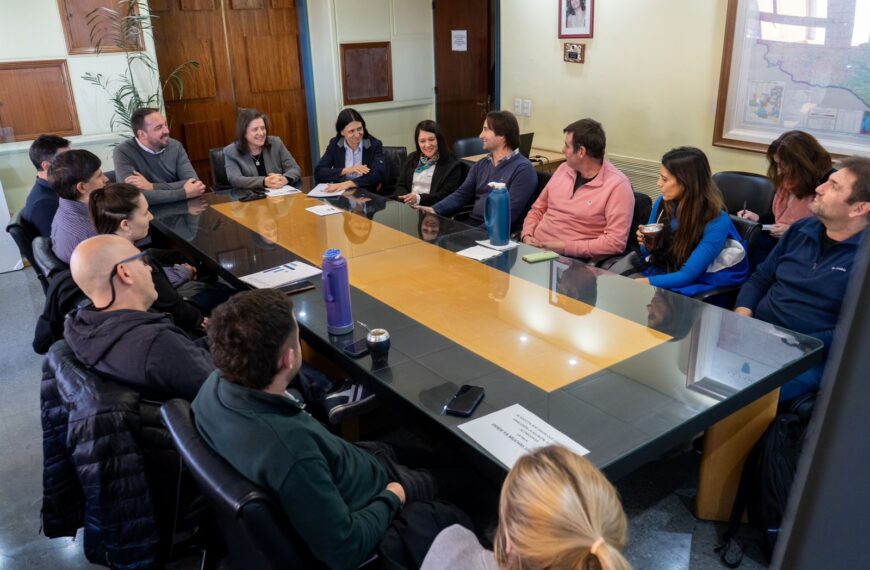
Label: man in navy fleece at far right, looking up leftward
xmin=734 ymin=157 xmax=870 ymax=401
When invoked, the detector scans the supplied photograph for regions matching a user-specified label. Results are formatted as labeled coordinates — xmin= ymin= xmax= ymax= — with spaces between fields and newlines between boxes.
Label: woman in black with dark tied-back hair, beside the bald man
xmin=88 ymin=183 xmax=232 ymax=336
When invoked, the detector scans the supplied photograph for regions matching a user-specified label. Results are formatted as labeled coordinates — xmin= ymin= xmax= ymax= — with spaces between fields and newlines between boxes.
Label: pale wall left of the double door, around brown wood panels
xmin=0 ymin=0 xmax=162 ymax=211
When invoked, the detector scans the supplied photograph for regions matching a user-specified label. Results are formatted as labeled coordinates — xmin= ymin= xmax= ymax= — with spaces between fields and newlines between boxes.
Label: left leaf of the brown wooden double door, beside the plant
xmin=149 ymin=0 xmax=235 ymax=185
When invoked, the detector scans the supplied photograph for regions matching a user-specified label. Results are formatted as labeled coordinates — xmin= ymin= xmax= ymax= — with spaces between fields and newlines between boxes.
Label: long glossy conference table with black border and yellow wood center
xmin=152 ymin=179 xmax=822 ymax=518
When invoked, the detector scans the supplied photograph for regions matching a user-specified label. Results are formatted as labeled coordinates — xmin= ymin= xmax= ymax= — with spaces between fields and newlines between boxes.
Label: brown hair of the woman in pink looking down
xmin=767 ymin=131 xmax=831 ymax=198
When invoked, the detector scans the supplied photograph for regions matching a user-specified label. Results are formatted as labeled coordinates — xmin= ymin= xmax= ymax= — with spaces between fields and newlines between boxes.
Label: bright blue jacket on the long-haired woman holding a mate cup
xmin=641 ymin=196 xmax=745 ymax=289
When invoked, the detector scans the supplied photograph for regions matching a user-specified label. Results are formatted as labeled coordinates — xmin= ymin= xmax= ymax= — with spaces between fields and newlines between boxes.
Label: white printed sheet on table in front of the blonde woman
xmin=459 ymin=404 xmax=589 ymax=469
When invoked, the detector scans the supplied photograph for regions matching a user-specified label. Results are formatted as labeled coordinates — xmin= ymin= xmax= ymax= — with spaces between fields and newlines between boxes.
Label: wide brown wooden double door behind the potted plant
xmin=149 ymin=0 xmax=311 ymax=184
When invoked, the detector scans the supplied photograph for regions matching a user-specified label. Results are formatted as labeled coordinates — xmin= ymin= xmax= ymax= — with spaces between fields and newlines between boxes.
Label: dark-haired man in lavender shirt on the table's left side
xmin=48 ymin=150 xmax=108 ymax=263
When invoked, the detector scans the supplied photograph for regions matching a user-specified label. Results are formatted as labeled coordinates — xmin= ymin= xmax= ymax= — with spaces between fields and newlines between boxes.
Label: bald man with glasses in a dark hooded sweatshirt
xmin=64 ymin=235 xmax=214 ymax=401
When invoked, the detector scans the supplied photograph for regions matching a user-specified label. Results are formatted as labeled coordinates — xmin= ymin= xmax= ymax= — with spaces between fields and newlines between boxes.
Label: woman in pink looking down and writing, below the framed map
xmin=737 ymin=131 xmax=834 ymax=235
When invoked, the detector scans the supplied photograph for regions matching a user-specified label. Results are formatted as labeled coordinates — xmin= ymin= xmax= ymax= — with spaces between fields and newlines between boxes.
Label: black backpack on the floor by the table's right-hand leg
xmin=716 ymin=392 xmax=816 ymax=568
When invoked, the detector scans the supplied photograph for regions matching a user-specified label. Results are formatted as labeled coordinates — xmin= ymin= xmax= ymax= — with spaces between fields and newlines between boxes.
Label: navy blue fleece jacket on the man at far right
xmin=736 ymin=216 xmax=864 ymax=400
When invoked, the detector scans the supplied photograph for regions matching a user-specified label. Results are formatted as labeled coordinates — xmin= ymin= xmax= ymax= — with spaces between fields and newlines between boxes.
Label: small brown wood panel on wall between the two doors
xmin=341 ymin=42 xmax=393 ymax=105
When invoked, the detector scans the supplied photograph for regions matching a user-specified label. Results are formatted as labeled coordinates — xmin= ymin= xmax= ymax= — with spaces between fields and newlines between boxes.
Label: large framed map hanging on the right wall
xmin=713 ymin=0 xmax=870 ymax=156
